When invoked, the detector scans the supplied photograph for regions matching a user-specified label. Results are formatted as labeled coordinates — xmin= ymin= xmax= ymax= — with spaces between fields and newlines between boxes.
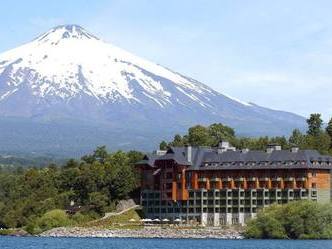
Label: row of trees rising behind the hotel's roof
xmin=159 ymin=113 xmax=332 ymax=155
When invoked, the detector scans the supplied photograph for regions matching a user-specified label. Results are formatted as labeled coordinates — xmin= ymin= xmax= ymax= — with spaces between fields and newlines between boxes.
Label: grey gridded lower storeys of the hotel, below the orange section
xmin=141 ymin=189 xmax=317 ymax=226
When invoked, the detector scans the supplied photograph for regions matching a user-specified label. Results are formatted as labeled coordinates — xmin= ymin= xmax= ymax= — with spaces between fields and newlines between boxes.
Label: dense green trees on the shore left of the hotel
xmin=0 ymin=150 xmax=143 ymax=233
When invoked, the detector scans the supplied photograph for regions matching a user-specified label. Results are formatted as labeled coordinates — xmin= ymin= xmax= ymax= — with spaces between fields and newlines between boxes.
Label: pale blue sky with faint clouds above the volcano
xmin=0 ymin=0 xmax=332 ymax=120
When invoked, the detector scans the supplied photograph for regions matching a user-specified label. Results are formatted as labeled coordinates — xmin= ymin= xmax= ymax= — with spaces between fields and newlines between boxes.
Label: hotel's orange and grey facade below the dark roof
xmin=141 ymin=164 xmax=332 ymax=226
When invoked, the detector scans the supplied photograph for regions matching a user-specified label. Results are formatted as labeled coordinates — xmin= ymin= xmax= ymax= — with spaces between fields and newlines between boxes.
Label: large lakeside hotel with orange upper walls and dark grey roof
xmin=137 ymin=142 xmax=332 ymax=226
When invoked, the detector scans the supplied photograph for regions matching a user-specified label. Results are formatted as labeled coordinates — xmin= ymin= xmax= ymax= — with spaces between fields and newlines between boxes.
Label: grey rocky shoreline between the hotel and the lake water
xmin=39 ymin=227 xmax=243 ymax=239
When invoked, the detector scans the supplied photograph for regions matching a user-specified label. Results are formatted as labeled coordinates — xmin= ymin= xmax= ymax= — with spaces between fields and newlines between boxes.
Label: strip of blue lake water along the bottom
xmin=0 ymin=236 xmax=332 ymax=249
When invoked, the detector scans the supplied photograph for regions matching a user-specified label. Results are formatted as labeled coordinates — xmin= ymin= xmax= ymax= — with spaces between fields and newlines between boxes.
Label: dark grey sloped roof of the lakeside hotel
xmin=136 ymin=147 xmax=332 ymax=170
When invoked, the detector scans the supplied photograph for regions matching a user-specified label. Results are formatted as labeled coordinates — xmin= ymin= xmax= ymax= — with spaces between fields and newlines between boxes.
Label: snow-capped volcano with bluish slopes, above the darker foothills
xmin=0 ymin=25 xmax=304 ymax=155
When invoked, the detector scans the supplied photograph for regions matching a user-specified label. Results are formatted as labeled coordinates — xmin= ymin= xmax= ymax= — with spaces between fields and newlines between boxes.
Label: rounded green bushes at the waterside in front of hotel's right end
xmin=245 ymin=201 xmax=332 ymax=239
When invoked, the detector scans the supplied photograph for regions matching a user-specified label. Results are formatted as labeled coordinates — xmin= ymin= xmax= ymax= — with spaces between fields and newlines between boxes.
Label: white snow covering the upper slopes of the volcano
xmin=0 ymin=25 xmax=226 ymax=107
